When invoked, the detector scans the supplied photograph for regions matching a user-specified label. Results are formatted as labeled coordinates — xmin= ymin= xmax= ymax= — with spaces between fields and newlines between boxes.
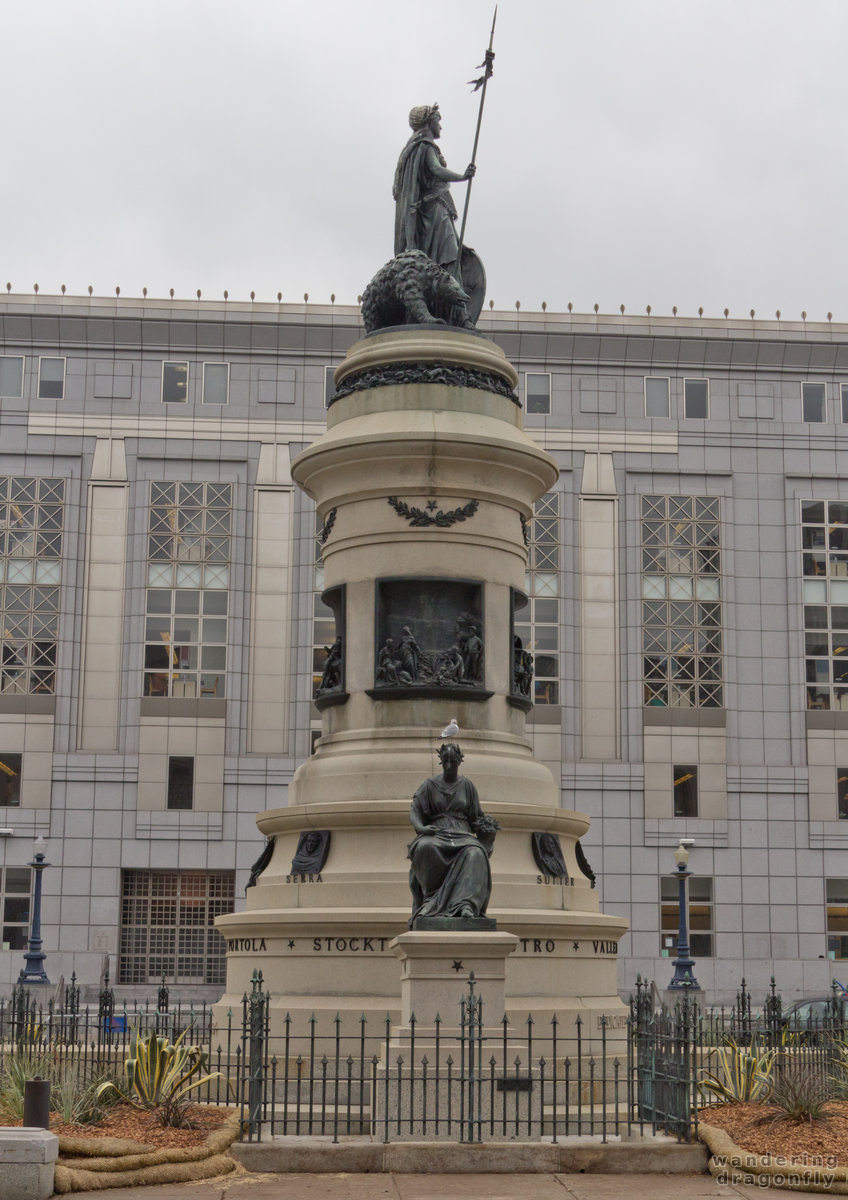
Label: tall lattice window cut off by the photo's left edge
xmin=0 ymin=476 xmax=65 ymax=695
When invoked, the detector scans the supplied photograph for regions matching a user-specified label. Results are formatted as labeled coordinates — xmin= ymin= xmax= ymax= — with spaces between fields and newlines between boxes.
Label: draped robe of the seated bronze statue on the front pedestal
xmin=409 ymin=775 xmax=492 ymax=925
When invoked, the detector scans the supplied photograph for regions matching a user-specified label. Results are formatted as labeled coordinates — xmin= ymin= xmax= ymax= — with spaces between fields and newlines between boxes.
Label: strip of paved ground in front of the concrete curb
xmin=62 ymin=1174 xmax=763 ymax=1200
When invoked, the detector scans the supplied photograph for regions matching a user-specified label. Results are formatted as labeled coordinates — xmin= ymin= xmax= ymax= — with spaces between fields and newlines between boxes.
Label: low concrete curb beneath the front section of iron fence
xmin=230 ymin=1136 xmax=709 ymax=1175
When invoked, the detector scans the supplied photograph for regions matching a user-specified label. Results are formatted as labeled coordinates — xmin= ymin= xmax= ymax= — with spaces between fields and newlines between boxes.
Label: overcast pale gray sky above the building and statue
xmin=0 ymin=0 xmax=848 ymax=320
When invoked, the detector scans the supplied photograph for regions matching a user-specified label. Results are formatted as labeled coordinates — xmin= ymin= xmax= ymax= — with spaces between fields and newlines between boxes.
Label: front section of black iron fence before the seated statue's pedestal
xmin=235 ymin=976 xmax=697 ymax=1142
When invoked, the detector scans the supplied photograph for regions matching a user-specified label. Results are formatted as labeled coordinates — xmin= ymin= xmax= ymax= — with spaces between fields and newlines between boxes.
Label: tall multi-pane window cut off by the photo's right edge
xmin=801 ymin=500 xmax=848 ymax=712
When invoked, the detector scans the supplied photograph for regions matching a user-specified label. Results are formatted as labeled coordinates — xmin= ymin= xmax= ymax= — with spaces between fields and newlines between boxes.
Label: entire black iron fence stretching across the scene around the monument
xmin=0 ymin=972 xmax=848 ymax=1142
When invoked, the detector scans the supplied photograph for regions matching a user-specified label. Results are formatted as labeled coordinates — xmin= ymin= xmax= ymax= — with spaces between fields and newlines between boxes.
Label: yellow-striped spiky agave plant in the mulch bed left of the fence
xmin=97 ymin=1028 xmax=224 ymax=1128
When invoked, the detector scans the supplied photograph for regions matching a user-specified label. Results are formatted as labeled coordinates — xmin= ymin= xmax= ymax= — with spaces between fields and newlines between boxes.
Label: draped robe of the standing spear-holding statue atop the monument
xmin=392 ymin=130 xmax=458 ymax=266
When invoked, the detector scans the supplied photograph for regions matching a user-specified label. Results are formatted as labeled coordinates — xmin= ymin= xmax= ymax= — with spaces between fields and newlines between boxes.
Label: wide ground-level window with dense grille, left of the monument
xmin=118 ymin=870 xmax=235 ymax=984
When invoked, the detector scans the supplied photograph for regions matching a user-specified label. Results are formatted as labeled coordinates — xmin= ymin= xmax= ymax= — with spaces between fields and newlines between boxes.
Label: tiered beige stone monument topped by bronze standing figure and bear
xmin=217 ymin=106 xmax=626 ymax=1050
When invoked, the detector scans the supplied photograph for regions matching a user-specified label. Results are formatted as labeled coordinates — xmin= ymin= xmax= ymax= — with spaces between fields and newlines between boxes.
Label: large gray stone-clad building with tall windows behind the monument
xmin=0 ymin=295 xmax=848 ymax=1002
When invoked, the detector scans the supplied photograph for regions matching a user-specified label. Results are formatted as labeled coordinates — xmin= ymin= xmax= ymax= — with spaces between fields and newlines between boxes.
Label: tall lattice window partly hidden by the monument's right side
xmin=515 ymin=492 xmax=560 ymax=704
